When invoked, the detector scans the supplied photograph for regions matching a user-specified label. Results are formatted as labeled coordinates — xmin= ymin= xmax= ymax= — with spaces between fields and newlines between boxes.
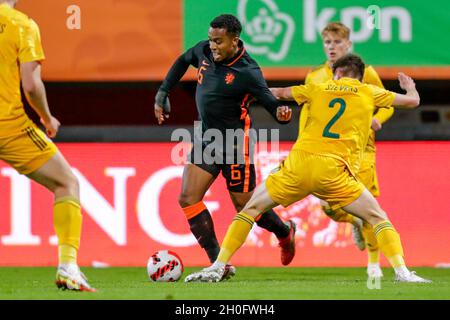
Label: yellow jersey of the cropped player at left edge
xmin=0 ymin=3 xmax=45 ymax=136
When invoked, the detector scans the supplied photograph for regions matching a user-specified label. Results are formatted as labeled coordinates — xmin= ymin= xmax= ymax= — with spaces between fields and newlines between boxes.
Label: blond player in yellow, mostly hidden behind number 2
xmin=284 ymin=22 xmax=394 ymax=278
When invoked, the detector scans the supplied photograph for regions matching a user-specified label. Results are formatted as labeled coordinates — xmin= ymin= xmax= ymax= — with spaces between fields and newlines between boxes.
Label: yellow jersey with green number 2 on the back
xmin=292 ymin=77 xmax=395 ymax=173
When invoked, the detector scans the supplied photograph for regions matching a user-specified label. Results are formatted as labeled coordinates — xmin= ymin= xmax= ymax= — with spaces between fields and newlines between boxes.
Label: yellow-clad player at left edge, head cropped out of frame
xmin=0 ymin=0 xmax=95 ymax=291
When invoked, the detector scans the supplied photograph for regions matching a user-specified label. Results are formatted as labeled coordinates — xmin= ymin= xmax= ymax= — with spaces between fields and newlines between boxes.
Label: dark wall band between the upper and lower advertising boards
xmin=26 ymin=80 xmax=450 ymax=141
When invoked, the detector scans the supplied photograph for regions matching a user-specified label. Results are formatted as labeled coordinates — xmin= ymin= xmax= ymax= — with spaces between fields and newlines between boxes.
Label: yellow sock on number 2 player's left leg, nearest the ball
xmin=217 ymin=212 xmax=255 ymax=264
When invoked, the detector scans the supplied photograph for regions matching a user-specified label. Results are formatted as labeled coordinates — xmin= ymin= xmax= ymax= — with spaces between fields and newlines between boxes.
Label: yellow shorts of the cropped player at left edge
xmin=0 ymin=120 xmax=58 ymax=174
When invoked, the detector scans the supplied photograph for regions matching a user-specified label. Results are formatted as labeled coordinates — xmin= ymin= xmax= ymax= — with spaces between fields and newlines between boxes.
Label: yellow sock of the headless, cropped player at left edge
xmin=53 ymin=197 xmax=82 ymax=264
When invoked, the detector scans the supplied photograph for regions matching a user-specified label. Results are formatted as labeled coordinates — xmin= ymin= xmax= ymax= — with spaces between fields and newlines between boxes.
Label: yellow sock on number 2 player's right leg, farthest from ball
xmin=373 ymin=220 xmax=405 ymax=268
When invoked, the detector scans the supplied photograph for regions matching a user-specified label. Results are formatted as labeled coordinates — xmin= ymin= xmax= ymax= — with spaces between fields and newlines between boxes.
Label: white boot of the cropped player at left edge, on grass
xmin=55 ymin=264 xmax=96 ymax=292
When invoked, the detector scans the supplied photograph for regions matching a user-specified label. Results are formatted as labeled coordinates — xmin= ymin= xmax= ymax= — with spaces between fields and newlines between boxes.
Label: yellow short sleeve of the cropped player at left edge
xmin=19 ymin=19 xmax=45 ymax=63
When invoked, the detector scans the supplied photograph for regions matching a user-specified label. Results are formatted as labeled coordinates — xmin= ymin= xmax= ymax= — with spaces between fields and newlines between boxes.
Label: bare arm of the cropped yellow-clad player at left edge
xmin=20 ymin=61 xmax=60 ymax=138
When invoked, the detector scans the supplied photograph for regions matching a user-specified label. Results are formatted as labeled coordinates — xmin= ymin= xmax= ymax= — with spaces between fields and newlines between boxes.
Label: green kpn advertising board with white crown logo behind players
xmin=183 ymin=0 xmax=444 ymax=67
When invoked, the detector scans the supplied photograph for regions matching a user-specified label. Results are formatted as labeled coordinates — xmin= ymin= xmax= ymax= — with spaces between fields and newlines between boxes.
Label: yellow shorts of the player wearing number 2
xmin=266 ymin=150 xmax=365 ymax=210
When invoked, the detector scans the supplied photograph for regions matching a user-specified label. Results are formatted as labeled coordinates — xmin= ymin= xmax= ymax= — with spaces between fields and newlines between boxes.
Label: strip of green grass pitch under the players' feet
xmin=0 ymin=267 xmax=450 ymax=300
